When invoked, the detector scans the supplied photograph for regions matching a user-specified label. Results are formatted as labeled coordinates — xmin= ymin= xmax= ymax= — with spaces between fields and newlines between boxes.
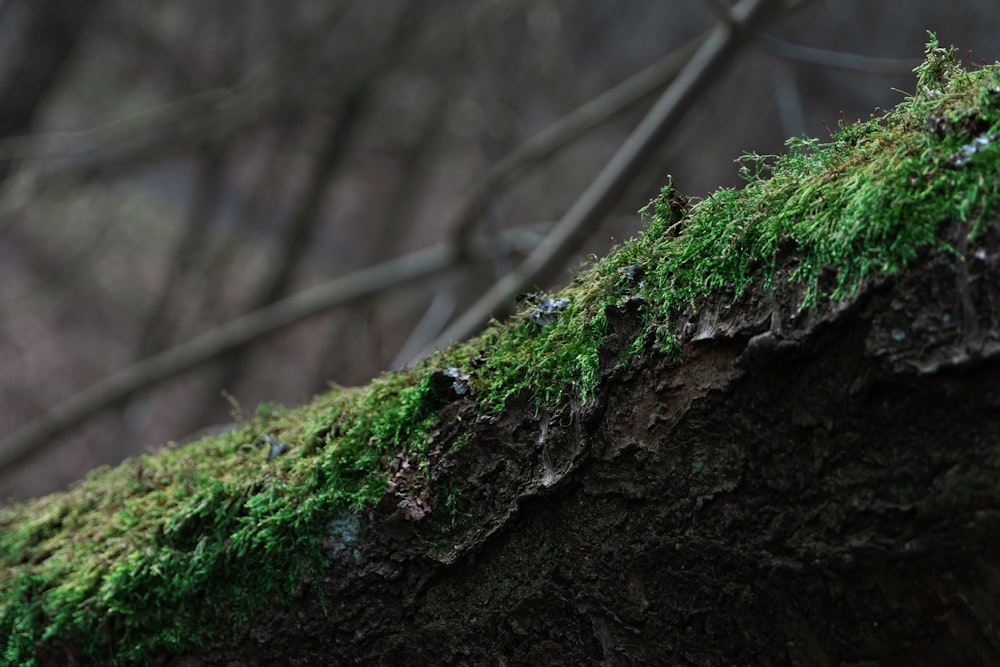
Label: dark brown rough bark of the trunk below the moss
xmin=131 ymin=218 xmax=1000 ymax=667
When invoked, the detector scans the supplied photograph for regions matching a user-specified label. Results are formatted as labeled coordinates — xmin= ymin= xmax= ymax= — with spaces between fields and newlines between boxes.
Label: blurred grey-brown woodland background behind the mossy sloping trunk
xmin=0 ymin=0 xmax=1000 ymax=502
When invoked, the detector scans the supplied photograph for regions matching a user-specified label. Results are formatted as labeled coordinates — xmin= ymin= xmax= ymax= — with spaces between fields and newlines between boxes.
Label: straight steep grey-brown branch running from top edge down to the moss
xmin=428 ymin=0 xmax=788 ymax=352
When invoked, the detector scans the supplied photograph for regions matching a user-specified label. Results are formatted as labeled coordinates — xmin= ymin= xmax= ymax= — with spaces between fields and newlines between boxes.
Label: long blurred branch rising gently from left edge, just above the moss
xmin=0 ymin=229 xmax=537 ymax=470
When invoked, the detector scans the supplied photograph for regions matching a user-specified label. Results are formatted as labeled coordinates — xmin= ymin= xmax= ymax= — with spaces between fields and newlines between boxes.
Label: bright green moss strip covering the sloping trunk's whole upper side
xmin=0 ymin=37 xmax=1000 ymax=665
